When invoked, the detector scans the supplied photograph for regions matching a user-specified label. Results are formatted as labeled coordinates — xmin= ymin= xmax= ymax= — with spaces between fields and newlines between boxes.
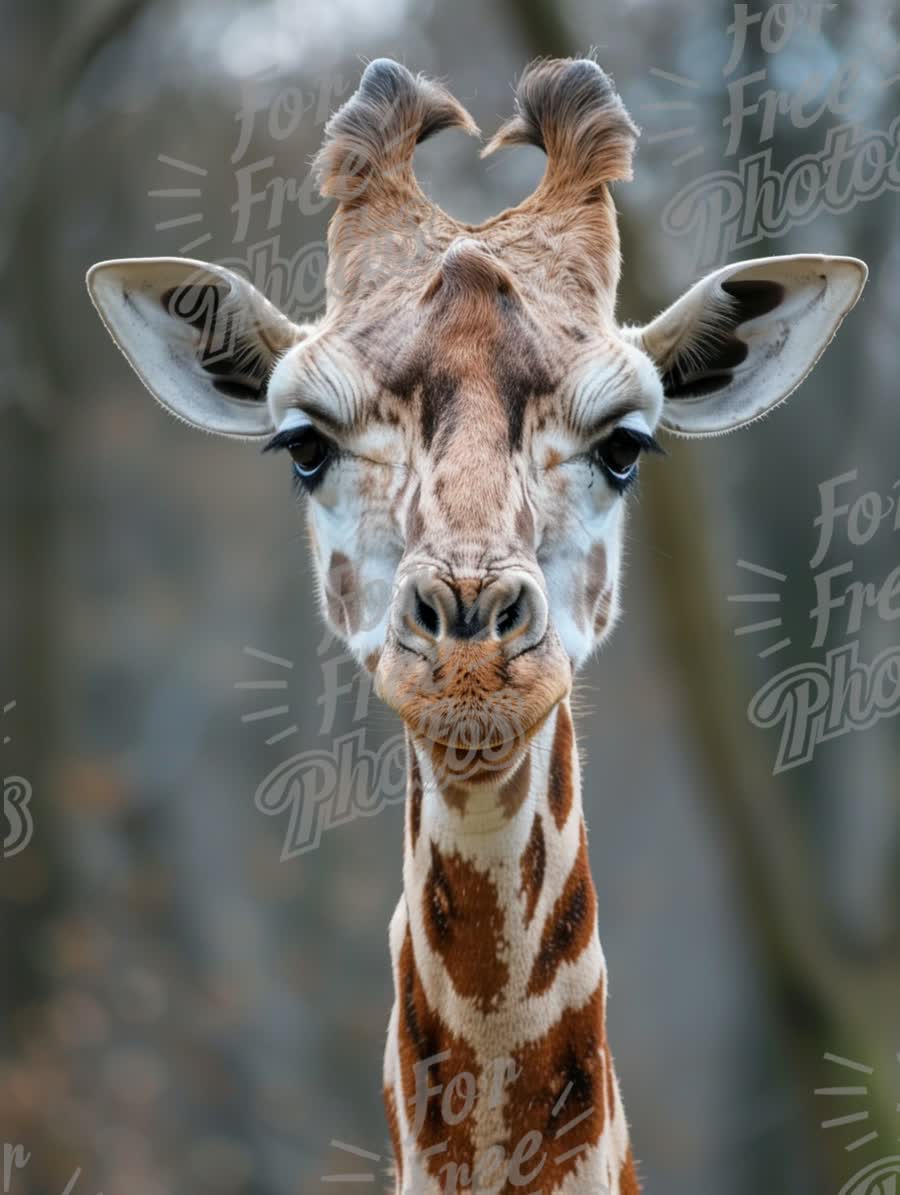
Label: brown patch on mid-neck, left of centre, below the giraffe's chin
xmin=422 ymin=842 xmax=509 ymax=1013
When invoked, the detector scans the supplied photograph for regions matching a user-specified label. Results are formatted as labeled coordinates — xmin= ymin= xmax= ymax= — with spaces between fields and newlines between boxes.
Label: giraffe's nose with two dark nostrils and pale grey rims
xmin=393 ymin=568 xmax=549 ymax=658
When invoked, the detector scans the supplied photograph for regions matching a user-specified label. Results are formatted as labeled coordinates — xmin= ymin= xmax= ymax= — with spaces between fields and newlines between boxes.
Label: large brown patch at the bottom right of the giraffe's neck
xmin=506 ymin=980 xmax=606 ymax=1195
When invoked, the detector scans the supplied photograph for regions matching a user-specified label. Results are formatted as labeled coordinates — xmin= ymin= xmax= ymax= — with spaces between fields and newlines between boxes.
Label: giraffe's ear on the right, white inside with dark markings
xmin=627 ymin=255 xmax=869 ymax=436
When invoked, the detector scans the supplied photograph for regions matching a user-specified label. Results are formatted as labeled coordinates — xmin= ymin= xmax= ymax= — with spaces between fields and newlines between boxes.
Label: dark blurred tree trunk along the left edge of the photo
xmin=0 ymin=0 xmax=154 ymax=1189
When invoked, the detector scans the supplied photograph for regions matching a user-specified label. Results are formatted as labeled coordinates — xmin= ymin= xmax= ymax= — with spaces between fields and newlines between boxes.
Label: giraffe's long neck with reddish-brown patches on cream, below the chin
xmin=385 ymin=704 xmax=638 ymax=1195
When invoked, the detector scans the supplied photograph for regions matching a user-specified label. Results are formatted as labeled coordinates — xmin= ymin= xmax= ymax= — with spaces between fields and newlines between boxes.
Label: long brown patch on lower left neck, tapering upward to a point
xmin=397 ymin=929 xmax=482 ymax=1176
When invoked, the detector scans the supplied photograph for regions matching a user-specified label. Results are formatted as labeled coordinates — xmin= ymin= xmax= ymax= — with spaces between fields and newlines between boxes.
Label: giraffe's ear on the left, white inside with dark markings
xmin=87 ymin=257 xmax=305 ymax=439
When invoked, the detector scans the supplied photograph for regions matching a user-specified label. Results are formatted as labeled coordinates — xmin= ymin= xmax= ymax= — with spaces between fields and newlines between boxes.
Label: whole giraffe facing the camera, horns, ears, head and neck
xmin=88 ymin=59 xmax=867 ymax=1195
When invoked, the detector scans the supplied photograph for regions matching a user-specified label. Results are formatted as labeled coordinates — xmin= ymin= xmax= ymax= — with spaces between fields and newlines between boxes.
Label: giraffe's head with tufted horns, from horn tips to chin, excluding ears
xmin=255 ymin=62 xmax=662 ymax=779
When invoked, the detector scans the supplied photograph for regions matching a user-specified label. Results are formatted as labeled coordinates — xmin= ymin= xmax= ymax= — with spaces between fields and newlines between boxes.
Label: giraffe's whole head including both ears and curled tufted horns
xmin=88 ymin=60 xmax=867 ymax=774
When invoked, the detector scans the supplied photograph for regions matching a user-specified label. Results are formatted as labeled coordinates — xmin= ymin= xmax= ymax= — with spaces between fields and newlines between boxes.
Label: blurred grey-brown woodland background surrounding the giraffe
xmin=0 ymin=0 xmax=900 ymax=1195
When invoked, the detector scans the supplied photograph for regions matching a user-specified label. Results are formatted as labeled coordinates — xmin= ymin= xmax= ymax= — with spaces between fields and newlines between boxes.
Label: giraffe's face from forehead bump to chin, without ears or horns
xmin=262 ymin=233 xmax=662 ymax=747
